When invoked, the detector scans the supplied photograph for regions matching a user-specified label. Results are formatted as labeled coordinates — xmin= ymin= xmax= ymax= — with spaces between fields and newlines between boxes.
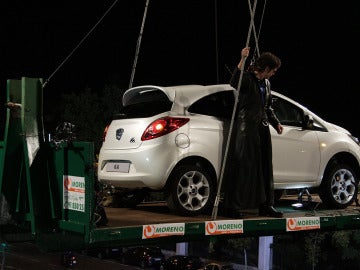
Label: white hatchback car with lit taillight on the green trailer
xmin=98 ymin=84 xmax=360 ymax=215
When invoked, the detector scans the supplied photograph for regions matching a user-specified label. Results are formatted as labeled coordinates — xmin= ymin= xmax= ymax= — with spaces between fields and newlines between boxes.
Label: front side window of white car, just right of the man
xmin=272 ymin=96 xmax=304 ymax=127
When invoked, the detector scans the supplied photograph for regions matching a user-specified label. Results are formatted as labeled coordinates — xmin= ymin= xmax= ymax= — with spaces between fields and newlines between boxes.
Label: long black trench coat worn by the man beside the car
xmin=223 ymin=69 xmax=279 ymax=210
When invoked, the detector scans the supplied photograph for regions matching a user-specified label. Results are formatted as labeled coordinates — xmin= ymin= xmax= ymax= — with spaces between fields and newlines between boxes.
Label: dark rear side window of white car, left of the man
xmin=188 ymin=91 xmax=235 ymax=119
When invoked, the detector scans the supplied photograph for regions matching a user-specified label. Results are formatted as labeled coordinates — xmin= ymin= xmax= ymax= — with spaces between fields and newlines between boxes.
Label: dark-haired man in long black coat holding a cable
xmin=224 ymin=48 xmax=283 ymax=218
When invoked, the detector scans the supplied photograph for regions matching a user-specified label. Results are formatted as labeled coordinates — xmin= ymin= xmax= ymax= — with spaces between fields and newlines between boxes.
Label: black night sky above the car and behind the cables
xmin=0 ymin=0 xmax=360 ymax=136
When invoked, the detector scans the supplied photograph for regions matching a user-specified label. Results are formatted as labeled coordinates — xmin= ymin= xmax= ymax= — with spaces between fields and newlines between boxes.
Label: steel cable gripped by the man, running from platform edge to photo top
xmin=211 ymin=0 xmax=266 ymax=220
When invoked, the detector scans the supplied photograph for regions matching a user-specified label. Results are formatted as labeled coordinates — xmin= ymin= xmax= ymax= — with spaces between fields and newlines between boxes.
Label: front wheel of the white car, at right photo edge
xmin=319 ymin=163 xmax=359 ymax=209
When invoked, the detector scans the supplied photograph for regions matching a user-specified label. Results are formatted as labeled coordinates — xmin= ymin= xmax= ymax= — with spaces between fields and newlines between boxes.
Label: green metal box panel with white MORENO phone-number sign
xmin=38 ymin=142 xmax=95 ymax=249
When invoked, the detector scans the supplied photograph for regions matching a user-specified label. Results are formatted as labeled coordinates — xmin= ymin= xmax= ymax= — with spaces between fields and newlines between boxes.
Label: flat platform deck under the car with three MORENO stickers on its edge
xmin=85 ymin=196 xmax=360 ymax=249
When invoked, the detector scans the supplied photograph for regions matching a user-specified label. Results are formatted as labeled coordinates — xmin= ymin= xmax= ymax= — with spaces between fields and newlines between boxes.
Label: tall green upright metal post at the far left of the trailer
xmin=0 ymin=78 xmax=43 ymax=235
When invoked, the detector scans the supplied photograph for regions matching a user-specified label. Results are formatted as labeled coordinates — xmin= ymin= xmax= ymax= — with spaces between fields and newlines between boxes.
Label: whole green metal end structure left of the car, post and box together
xmin=0 ymin=78 xmax=95 ymax=249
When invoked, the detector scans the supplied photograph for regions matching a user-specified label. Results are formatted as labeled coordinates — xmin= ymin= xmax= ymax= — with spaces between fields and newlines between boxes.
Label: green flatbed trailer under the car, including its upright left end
xmin=0 ymin=77 xmax=360 ymax=255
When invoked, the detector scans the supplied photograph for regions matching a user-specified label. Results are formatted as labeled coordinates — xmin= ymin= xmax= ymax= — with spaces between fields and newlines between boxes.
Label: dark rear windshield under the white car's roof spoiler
xmin=114 ymin=89 xmax=172 ymax=119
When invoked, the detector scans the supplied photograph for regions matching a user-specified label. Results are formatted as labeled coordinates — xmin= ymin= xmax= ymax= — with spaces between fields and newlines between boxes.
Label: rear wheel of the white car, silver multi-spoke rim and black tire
xmin=166 ymin=165 xmax=216 ymax=216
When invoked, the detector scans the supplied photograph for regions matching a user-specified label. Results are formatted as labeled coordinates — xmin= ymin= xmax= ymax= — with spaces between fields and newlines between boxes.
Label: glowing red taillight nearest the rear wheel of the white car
xmin=141 ymin=116 xmax=190 ymax=141
